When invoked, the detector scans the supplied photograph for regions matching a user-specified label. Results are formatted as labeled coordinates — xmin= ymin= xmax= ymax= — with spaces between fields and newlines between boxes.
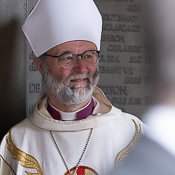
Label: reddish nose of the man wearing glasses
xmin=73 ymin=56 xmax=87 ymax=73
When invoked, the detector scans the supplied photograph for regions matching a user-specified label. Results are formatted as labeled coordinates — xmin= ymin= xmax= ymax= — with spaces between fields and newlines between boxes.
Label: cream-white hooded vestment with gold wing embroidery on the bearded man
xmin=0 ymin=88 xmax=146 ymax=175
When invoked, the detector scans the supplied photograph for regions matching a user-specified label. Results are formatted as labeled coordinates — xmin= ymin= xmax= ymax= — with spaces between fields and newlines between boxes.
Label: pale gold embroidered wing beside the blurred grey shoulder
xmin=115 ymin=119 xmax=142 ymax=165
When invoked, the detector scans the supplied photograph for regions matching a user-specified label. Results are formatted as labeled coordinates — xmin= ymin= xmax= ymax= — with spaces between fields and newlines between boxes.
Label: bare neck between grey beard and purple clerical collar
xmin=48 ymin=95 xmax=91 ymax=112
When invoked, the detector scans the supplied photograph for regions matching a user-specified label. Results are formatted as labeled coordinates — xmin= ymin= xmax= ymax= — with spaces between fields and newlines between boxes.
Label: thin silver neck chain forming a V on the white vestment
xmin=50 ymin=128 xmax=93 ymax=175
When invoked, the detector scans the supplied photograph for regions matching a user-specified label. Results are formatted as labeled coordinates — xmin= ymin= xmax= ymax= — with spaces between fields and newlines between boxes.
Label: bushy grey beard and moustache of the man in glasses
xmin=44 ymin=65 xmax=99 ymax=106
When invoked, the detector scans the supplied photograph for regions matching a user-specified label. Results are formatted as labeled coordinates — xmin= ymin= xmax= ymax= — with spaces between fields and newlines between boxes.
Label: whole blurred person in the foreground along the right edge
xmin=113 ymin=0 xmax=175 ymax=175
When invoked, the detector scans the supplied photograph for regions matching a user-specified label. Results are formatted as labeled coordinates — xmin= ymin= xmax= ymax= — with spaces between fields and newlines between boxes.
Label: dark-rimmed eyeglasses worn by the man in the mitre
xmin=43 ymin=50 xmax=100 ymax=69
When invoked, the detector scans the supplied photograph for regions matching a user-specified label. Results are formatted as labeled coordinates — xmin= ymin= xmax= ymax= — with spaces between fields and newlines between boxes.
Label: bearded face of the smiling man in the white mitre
xmin=40 ymin=41 xmax=99 ymax=105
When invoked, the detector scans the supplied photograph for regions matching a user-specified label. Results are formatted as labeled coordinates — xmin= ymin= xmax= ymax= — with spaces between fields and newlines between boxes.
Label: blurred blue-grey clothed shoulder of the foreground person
xmin=110 ymin=136 xmax=175 ymax=175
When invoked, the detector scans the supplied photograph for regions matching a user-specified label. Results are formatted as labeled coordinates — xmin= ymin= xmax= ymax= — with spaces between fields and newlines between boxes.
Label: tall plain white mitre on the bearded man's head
xmin=22 ymin=0 xmax=102 ymax=57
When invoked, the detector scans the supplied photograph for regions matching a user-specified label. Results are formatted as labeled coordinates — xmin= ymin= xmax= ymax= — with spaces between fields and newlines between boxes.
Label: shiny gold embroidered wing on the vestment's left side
xmin=6 ymin=130 xmax=44 ymax=175
